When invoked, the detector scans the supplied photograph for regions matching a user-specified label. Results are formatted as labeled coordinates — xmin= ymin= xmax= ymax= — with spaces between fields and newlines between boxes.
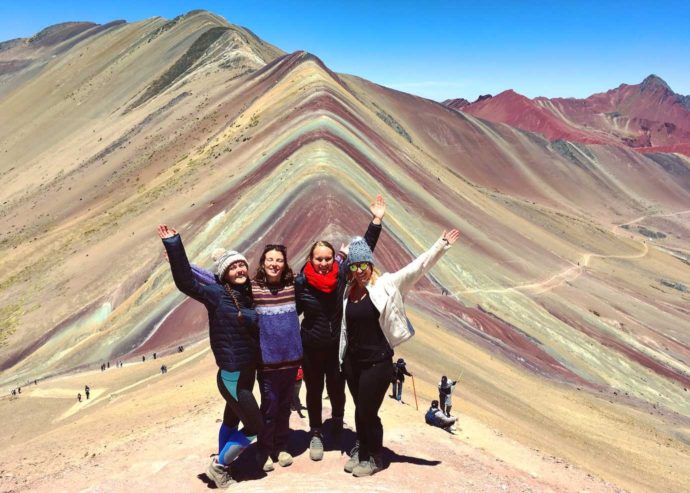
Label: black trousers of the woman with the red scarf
xmin=302 ymin=345 xmax=345 ymax=428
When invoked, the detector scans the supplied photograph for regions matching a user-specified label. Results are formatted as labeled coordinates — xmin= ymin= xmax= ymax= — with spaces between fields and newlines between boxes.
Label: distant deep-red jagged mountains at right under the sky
xmin=444 ymin=75 xmax=690 ymax=155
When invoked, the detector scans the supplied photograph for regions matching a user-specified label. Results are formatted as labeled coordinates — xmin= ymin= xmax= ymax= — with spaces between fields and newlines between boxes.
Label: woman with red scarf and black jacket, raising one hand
xmin=295 ymin=195 xmax=386 ymax=460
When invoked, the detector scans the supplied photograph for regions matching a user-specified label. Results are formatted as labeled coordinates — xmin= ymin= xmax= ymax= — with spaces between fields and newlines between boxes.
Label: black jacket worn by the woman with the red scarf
xmin=295 ymin=223 xmax=382 ymax=350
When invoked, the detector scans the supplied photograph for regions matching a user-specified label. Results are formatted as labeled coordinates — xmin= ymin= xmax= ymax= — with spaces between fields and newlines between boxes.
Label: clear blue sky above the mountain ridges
xmin=0 ymin=0 xmax=690 ymax=100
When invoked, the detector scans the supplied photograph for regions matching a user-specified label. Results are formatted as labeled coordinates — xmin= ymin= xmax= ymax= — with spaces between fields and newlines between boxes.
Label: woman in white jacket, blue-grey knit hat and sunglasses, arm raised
xmin=339 ymin=229 xmax=460 ymax=477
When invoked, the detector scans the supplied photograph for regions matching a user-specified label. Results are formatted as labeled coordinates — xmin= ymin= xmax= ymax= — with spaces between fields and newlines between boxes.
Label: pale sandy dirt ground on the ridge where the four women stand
xmin=0 ymin=347 xmax=620 ymax=493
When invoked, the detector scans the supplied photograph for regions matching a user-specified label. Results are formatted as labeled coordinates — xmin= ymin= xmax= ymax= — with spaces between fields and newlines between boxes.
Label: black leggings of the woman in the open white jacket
xmin=343 ymin=358 xmax=393 ymax=461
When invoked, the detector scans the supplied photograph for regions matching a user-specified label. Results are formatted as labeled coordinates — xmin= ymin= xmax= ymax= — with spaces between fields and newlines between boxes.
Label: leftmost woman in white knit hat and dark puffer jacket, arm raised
xmin=158 ymin=225 xmax=260 ymax=488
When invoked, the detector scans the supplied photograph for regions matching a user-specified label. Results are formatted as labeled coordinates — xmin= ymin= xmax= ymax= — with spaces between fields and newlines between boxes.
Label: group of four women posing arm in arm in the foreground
xmin=158 ymin=196 xmax=460 ymax=488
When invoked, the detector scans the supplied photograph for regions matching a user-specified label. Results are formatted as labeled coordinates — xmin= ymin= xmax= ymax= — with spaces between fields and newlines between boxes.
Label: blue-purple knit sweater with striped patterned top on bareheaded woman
xmin=252 ymin=281 xmax=302 ymax=370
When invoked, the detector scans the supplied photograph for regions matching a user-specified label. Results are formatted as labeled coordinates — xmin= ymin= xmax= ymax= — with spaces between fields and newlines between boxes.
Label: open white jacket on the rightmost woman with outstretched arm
xmin=340 ymin=239 xmax=450 ymax=364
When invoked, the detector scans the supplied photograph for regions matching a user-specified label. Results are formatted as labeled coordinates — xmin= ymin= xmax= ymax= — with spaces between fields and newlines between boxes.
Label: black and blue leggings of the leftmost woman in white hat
xmin=216 ymin=368 xmax=263 ymax=465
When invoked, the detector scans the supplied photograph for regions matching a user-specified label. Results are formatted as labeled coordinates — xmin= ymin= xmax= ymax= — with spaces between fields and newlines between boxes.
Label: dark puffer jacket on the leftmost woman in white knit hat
xmin=163 ymin=235 xmax=260 ymax=371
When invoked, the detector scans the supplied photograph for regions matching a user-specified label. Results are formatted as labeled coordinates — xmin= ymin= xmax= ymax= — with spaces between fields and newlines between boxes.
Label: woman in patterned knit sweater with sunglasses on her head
xmin=189 ymin=244 xmax=302 ymax=472
